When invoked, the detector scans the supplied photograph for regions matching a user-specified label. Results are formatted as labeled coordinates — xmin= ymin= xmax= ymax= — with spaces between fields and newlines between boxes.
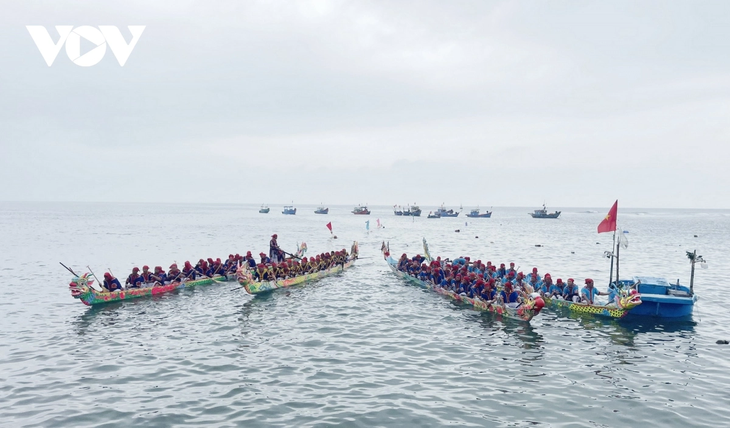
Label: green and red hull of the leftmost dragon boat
xmin=68 ymin=273 xmax=228 ymax=306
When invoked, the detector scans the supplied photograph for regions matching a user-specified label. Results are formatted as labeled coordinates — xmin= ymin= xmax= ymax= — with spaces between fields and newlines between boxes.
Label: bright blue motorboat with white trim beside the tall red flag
xmin=619 ymin=276 xmax=698 ymax=318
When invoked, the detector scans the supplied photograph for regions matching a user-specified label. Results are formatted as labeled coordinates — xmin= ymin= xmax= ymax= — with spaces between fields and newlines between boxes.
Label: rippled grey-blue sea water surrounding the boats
xmin=0 ymin=202 xmax=730 ymax=428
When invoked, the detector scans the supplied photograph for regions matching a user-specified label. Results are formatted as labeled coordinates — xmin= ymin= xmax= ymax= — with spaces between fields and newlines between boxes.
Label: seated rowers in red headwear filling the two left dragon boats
xmin=103 ymin=249 xmax=349 ymax=291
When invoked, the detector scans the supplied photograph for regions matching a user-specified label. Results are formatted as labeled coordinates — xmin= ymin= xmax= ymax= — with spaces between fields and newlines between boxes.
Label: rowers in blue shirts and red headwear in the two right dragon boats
xmin=398 ymin=254 xmax=617 ymax=305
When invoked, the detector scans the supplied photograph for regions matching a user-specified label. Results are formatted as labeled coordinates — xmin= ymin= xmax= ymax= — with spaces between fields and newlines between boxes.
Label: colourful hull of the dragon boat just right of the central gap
xmin=381 ymin=239 xmax=545 ymax=322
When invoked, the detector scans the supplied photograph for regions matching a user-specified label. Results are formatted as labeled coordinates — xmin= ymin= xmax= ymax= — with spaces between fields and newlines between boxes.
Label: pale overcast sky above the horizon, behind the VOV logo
xmin=0 ymin=0 xmax=730 ymax=209
